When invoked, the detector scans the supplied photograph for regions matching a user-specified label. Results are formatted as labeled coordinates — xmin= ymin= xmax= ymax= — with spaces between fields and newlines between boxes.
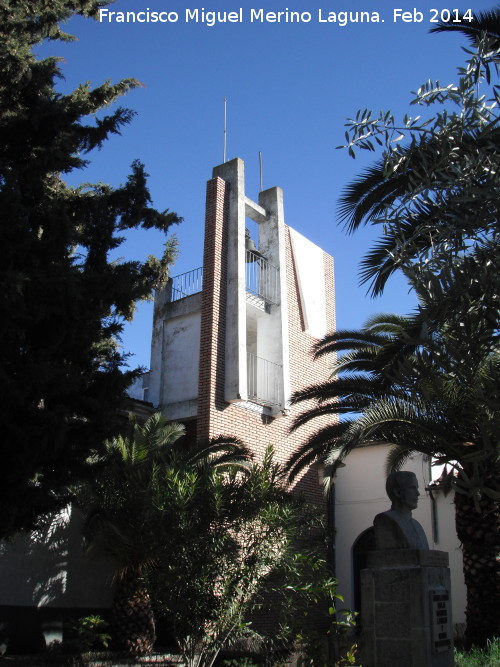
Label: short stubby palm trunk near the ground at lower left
xmin=111 ymin=572 xmax=156 ymax=655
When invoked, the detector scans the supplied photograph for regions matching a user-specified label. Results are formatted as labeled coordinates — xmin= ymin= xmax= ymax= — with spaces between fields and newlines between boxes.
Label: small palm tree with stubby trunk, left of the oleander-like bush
xmin=75 ymin=413 xmax=249 ymax=655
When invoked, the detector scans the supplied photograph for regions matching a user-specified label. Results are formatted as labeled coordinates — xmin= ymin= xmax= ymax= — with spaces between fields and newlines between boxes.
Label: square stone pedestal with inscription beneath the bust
xmin=361 ymin=549 xmax=453 ymax=667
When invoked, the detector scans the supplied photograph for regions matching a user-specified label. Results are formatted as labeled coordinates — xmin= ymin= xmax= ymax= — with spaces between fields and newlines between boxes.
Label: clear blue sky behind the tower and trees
xmin=37 ymin=0 xmax=468 ymax=366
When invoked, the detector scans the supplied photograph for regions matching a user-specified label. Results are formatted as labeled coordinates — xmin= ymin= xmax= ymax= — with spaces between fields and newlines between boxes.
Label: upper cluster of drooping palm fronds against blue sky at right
xmin=339 ymin=126 xmax=500 ymax=296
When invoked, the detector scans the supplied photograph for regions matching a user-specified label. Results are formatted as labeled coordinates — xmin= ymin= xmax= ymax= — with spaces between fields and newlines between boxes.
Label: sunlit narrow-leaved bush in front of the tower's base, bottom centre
xmin=151 ymin=451 xmax=336 ymax=666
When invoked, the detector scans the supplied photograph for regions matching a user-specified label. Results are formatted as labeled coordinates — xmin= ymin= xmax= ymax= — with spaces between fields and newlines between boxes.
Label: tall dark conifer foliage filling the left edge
xmin=0 ymin=0 xmax=180 ymax=537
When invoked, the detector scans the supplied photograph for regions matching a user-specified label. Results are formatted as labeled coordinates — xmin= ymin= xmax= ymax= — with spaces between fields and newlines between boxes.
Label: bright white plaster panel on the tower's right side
xmin=290 ymin=228 xmax=326 ymax=338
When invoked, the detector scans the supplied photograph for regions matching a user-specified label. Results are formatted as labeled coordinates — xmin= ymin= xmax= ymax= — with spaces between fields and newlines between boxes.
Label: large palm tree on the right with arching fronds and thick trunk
xmin=330 ymin=27 xmax=500 ymax=643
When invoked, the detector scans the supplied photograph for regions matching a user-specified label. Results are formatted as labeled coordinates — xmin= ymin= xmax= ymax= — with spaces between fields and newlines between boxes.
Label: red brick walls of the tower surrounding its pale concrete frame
xmin=198 ymin=177 xmax=335 ymax=504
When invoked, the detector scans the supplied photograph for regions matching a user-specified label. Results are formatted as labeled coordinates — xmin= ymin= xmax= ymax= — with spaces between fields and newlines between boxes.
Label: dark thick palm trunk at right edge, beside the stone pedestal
xmin=455 ymin=482 xmax=500 ymax=647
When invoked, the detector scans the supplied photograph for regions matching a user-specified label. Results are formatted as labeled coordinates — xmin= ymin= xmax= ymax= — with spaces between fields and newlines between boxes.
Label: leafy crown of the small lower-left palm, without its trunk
xmin=73 ymin=412 xmax=248 ymax=576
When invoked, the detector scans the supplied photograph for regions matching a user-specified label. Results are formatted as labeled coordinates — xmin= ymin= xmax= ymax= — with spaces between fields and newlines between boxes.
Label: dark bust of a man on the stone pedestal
xmin=373 ymin=470 xmax=429 ymax=550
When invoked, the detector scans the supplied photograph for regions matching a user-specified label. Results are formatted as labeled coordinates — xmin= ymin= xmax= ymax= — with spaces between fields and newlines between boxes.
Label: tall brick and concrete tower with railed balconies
xmin=145 ymin=159 xmax=335 ymax=500
